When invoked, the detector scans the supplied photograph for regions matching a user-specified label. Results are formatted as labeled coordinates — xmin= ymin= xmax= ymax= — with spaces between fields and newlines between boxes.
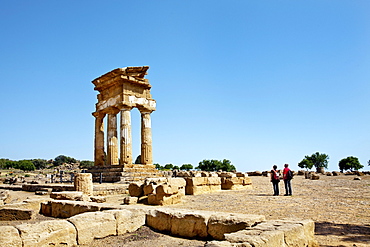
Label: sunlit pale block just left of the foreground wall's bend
xmin=105 ymin=210 xmax=146 ymax=235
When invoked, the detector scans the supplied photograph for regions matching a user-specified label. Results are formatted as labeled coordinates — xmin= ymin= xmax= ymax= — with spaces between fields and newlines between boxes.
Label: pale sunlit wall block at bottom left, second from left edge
xmin=16 ymin=220 xmax=77 ymax=247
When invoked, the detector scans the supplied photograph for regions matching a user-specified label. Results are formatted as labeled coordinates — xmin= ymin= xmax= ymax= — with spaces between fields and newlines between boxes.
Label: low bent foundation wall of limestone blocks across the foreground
xmin=0 ymin=202 xmax=318 ymax=247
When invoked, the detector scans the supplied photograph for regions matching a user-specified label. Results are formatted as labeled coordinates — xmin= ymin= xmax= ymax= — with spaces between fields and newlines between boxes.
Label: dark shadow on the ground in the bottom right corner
xmin=315 ymin=222 xmax=370 ymax=246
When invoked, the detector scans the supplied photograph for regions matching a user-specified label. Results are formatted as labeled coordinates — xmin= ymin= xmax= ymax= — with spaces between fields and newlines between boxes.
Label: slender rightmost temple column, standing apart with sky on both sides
xmin=140 ymin=110 xmax=153 ymax=165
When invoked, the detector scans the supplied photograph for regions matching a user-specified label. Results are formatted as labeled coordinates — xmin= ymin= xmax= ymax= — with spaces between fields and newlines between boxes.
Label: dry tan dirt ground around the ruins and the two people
xmin=0 ymin=175 xmax=370 ymax=247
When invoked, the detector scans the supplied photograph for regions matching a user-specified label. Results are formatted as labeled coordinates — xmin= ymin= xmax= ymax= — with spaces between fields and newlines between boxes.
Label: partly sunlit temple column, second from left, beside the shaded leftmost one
xmin=107 ymin=111 xmax=118 ymax=165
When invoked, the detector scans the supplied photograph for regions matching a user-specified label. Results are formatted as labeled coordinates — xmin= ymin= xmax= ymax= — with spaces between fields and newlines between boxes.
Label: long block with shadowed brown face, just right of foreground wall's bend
xmin=147 ymin=208 xmax=212 ymax=238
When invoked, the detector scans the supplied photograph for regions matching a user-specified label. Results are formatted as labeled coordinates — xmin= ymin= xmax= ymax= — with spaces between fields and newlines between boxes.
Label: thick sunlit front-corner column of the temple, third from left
xmin=120 ymin=107 xmax=132 ymax=165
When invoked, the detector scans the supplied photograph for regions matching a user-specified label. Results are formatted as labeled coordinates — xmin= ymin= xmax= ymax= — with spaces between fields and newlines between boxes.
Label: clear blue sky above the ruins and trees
xmin=0 ymin=0 xmax=370 ymax=171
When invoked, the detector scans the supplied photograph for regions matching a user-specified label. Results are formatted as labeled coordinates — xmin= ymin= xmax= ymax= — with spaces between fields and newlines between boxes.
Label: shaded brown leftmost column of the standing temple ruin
xmin=93 ymin=112 xmax=105 ymax=166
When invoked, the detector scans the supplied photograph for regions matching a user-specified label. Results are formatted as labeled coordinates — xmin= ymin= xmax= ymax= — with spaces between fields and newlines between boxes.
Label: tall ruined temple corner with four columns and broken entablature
xmin=89 ymin=66 xmax=163 ymax=182
